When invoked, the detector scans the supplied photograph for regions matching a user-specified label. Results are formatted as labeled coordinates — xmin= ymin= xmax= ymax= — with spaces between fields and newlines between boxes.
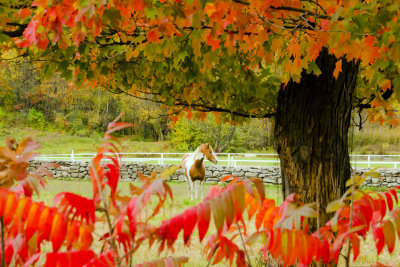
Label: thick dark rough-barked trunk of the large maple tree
xmin=274 ymin=48 xmax=359 ymax=225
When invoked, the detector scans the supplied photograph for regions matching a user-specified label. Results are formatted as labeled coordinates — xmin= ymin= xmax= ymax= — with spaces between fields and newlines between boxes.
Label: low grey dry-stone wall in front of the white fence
xmin=31 ymin=161 xmax=400 ymax=187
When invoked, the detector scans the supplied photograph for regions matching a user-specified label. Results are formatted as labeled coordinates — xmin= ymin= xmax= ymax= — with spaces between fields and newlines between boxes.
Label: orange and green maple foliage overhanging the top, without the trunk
xmin=0 ymin=0 xmax=400 ymax=123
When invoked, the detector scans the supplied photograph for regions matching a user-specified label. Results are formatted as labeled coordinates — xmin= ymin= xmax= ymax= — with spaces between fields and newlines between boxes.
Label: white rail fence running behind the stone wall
xmin=32 ymin=151 xmax=400 ymax=168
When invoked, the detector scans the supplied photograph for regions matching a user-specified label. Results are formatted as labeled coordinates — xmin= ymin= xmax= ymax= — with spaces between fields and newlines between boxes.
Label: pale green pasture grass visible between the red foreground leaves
xmin=35 ymin=179 xmax=400 ymax=266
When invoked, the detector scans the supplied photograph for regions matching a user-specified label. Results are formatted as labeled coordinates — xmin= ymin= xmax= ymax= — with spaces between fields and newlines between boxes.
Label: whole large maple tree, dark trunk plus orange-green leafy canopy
xmin=0 ymin=0 xmax=400 ymax=225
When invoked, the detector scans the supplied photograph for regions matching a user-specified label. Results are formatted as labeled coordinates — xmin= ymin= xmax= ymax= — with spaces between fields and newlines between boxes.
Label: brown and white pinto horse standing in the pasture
xmin=181 ymin=143 xmax=218 ymax=200
